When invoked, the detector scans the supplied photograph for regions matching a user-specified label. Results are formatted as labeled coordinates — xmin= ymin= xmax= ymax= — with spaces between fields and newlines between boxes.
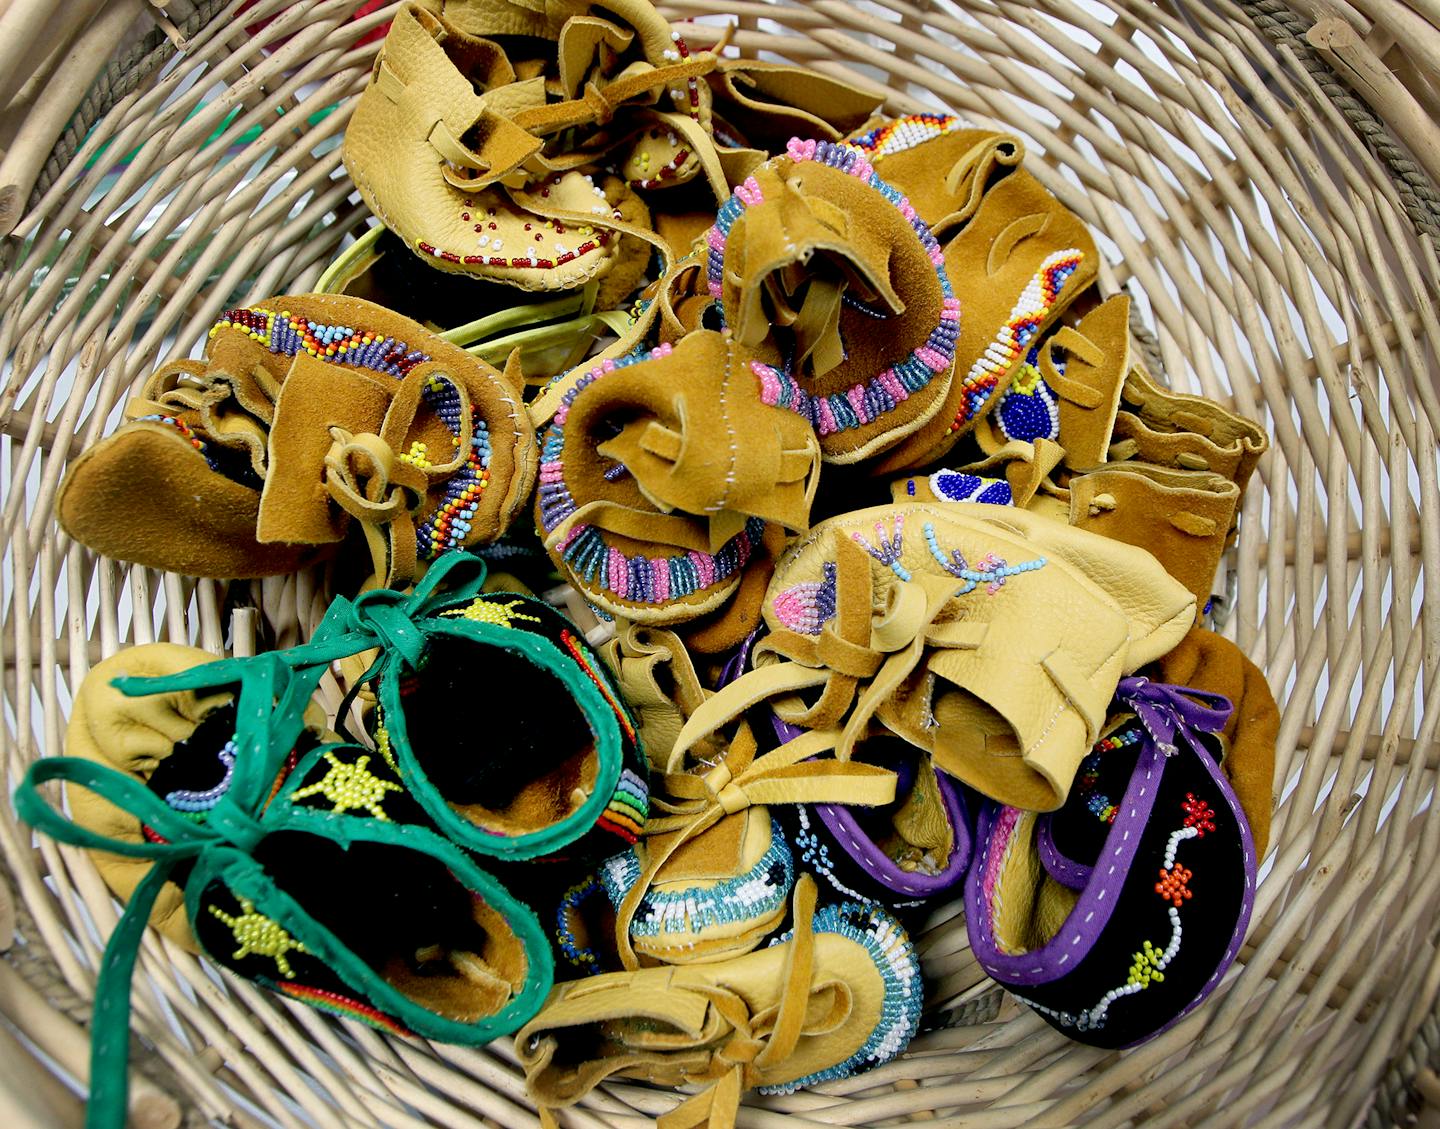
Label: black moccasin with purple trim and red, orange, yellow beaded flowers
xmin=965 ymin=678 xmax=1256 ymax=1047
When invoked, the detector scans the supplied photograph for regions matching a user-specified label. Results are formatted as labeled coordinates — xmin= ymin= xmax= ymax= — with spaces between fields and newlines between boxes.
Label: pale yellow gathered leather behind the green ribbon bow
xmin=65 ymin=642 xmax=333 ymax=950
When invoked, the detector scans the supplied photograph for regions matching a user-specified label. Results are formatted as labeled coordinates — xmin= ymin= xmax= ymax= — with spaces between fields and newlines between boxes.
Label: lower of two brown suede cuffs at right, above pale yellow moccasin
xmin=1070 ymin=462 xmax=1240 ymax=613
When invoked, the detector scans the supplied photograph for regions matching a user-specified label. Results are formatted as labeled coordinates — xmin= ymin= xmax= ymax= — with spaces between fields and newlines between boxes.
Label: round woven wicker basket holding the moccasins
xmin=0 ymin=0 xmax=1440 ymax=1129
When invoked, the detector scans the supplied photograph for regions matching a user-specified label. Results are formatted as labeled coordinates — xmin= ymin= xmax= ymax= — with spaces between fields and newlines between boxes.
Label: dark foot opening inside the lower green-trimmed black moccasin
xmin=255 ymin=832 xmax=526 ymax=1022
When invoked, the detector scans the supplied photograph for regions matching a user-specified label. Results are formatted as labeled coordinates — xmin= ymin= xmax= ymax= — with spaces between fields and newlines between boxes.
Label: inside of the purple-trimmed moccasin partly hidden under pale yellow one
xmin=848 ymin=736 xmax=955 ymax=876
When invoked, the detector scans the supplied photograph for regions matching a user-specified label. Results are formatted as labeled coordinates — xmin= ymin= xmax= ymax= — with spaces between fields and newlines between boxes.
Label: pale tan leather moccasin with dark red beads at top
xmin=344 ymin=0 xmax=714 ymax=282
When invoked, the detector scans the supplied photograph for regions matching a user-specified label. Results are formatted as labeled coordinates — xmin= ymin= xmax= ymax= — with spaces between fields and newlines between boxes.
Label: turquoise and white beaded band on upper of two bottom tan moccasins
xmin=600 ymin=824 xmax=795 ymax=940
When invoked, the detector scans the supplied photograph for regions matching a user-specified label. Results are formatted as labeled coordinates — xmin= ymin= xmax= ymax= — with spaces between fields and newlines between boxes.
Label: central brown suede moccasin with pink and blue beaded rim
xmin=536 ymin=330 xmax=819 ymax=624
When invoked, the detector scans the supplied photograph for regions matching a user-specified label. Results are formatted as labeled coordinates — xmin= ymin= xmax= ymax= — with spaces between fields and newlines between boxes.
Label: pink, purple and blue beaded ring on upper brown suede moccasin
xmin=706 ymin=138 xmax=960 ymax=435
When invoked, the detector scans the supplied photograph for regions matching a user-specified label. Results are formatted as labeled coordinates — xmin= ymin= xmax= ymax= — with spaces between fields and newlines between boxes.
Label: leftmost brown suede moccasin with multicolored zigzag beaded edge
xmin=56 ymin=295 xmax=534 ymax=585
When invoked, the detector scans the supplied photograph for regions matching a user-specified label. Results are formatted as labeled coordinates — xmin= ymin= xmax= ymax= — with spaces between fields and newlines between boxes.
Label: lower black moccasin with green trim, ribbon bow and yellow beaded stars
xmin=16 ymin=652 xmax=553 ymax=1129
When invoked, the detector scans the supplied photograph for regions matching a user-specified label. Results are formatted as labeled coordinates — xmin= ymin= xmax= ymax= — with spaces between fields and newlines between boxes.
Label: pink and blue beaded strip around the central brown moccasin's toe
xmin=537 ymin=343 xmax=765 ymax=605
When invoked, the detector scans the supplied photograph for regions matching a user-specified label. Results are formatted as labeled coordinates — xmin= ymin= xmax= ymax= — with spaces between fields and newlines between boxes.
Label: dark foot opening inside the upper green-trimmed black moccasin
xmin=402 ymin=635 xmax=599 ymax=835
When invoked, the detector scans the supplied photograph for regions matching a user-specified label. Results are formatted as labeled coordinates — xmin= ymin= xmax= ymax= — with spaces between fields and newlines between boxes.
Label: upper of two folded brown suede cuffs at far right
xmin=1110 ymin=363 xmax=1270 ymax=495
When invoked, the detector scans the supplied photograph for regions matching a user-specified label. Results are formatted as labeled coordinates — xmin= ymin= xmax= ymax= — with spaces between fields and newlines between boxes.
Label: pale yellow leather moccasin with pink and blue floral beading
xmin=672 ymin=503 xmax=1195 ymax=809
